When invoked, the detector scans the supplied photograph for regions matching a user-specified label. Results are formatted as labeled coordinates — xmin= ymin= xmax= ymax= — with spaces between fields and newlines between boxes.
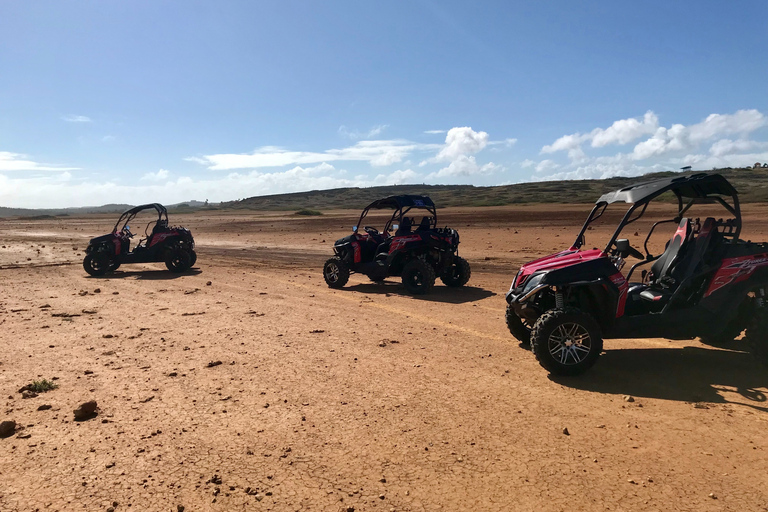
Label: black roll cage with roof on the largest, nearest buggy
xmin=572 ymin=173 xmax=741 ymax=258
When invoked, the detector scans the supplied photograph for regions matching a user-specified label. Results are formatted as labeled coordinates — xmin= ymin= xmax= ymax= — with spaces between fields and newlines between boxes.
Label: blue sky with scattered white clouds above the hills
xmin=0 ymin=0 xmax=768 ymax=207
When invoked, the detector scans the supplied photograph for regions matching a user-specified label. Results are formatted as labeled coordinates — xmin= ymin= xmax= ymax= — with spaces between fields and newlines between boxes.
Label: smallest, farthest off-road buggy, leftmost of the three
xmin=83 ymin=203 xmax=197 ymax=276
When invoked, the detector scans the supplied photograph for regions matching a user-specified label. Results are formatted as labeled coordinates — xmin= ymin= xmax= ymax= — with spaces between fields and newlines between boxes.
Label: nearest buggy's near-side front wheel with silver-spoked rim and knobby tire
xmin=531 ymin=308 xmax=603 ymax=375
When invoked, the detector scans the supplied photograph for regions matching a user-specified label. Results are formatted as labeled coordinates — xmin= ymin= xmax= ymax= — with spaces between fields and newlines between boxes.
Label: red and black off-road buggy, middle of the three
xmin=323 ymin=195 xmax=471 ymax=294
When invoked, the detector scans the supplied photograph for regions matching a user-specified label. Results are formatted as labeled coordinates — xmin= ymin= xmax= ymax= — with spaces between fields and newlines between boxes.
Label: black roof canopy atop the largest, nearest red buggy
xmin=597 ymin=173 xmax=738 ymax=204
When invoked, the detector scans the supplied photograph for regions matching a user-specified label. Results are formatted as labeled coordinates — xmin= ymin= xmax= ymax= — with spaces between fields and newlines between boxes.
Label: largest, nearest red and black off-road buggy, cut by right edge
xmin=506 ymin=173 xmax=768 ymax=375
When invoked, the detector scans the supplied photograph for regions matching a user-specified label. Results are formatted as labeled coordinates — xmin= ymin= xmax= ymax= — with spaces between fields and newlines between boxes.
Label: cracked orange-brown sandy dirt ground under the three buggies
xmin=0 ymin=206 xmax=768 ymax=512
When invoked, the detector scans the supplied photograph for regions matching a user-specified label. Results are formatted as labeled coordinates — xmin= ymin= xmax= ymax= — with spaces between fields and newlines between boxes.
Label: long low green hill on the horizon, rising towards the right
xmin=218 ymin=168 xmax=768 ymax=210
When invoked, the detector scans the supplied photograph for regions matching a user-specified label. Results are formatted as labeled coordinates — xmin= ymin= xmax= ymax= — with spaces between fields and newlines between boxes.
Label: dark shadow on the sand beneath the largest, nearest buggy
xmin=550 ymin=347 xmax=768 ymax=412
